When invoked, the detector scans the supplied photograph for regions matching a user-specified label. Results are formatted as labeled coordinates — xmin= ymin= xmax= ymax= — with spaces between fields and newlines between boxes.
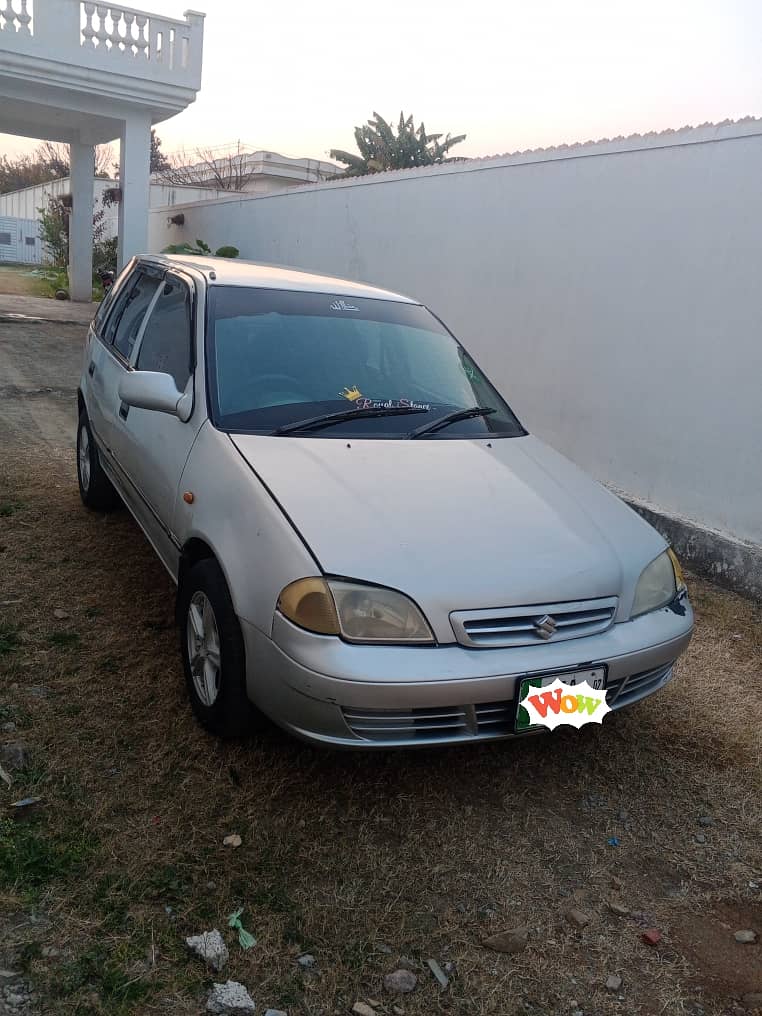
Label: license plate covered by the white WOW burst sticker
xmin=515 ymin=666 xmax=611 ymax=734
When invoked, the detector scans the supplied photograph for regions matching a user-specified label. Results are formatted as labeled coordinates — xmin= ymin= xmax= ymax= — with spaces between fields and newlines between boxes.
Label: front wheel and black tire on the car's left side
xmin=178 ymin=558 xmax=261 ymax=739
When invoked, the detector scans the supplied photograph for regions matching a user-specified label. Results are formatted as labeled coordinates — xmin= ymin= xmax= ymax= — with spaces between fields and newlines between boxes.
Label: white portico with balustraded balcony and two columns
xmin=0 ymin=0 xmax=204 ymax=301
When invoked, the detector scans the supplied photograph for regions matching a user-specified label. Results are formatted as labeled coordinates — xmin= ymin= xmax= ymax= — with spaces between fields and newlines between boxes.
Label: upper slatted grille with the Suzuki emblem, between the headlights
xmin=450 ymin=596 xmax=617 ymax=648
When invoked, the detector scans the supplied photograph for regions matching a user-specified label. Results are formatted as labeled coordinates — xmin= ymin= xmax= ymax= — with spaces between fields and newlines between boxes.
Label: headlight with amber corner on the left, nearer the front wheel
xmin=277 ymin=578 xmax=434 ymax=645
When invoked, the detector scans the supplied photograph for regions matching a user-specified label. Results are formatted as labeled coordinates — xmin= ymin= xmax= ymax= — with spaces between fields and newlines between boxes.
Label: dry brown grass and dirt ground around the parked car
xmin=0 ymin=312 xmax=762 ymax=1016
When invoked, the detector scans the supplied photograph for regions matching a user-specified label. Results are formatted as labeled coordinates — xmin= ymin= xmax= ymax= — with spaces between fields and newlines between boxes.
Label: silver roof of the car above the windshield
xmin=140 ymin=254 xmax=418 ymax=304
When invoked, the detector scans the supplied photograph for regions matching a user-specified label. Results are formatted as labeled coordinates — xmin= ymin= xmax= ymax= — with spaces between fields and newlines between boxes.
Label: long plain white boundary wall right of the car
xmin=149 ymin=120 xmax=762 ymax=545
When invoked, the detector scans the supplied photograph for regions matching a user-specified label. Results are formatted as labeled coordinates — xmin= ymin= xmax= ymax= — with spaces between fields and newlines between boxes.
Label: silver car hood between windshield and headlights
xmin=231 ymin=434 xmax=665 ymax=641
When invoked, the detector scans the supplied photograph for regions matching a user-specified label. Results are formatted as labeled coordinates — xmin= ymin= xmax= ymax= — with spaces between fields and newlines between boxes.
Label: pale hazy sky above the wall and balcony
xmin=0 ymin=0 xmax=762 ymax=158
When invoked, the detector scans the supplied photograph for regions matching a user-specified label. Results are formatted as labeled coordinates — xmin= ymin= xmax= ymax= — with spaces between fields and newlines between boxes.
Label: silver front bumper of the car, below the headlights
xmin=241 ymin=596 xmax=693 ymax=748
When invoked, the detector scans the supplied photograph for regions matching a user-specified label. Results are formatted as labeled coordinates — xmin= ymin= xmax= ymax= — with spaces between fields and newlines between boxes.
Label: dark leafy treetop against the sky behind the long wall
xmin=330 ymin=113 xmax=465 ymax=177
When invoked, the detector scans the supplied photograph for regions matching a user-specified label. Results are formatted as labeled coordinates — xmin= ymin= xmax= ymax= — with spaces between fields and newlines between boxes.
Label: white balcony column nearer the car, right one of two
xmin=119 ymin=114 xmax=150 ymax=269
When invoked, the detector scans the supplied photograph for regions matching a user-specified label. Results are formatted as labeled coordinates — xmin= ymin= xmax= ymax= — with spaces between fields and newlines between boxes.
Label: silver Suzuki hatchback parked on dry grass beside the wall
xmin=77 ymin=256 xmax=693 ymax=748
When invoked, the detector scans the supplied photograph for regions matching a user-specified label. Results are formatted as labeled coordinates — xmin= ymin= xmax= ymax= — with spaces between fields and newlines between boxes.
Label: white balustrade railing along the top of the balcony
xmin=0 ymin=0 xmax=204 ymax=89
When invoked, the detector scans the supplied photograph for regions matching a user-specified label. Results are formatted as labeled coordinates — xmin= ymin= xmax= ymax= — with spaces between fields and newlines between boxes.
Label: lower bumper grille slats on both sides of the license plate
xmin=341 ymin=663 xmax=674 ymax=744
